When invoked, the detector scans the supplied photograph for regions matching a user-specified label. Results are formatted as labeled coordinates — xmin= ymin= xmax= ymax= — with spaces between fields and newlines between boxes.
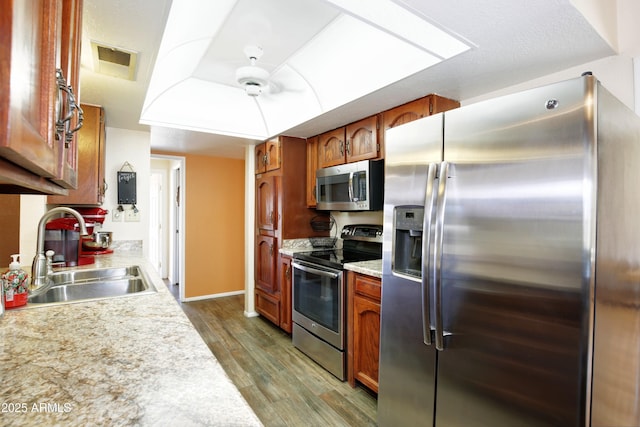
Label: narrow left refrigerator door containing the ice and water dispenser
xmin=378 ymin=114 xmax=443 ymax=427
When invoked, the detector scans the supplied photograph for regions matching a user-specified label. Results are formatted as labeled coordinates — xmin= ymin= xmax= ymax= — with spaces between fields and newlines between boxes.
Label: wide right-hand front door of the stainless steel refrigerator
xmin=435 ymin=79 xmax=594 ymax=427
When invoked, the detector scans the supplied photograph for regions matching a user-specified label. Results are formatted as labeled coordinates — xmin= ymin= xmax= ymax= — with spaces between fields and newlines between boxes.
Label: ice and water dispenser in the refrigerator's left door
xmin=392 ymin=206 xmax=424 ymax=279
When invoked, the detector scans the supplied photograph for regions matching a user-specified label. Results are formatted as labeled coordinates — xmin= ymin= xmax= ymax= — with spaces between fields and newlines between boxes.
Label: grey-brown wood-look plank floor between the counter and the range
xmin=169 ymin=285 xmax=377 ymax=427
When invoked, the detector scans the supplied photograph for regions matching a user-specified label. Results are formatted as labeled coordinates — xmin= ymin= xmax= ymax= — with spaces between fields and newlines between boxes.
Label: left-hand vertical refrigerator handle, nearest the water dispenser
xmin=421 ymin=163 xmax=438 ymax=345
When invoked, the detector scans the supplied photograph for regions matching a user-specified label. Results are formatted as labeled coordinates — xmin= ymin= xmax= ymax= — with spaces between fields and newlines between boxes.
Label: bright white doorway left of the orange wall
xmin=149 ymin=154 xmax=185 ymax=301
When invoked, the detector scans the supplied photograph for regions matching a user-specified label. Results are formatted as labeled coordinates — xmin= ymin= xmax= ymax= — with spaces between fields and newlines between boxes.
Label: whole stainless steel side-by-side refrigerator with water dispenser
xmin=378 ymin=75 xmax=640 ymax=427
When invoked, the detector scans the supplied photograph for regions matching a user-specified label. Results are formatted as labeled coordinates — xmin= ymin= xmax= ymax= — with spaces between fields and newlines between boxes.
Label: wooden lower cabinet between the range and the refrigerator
xmin=347 ymin=271 xmax=382 ymax=393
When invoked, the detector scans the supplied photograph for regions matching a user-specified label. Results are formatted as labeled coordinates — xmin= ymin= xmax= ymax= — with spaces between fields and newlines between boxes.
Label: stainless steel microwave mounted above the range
xmin=316 ymin=160 xmax=384 ymax=211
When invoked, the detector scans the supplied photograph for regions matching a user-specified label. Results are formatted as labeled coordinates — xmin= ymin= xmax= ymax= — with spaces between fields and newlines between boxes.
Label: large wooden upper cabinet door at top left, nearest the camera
xmin=0 ymin=0 xmax=62 ymax=178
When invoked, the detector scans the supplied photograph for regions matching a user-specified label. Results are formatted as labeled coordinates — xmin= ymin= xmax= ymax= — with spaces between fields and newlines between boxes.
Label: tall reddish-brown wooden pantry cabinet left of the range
xmin=255 ymin=136 xmax=318 ymax=332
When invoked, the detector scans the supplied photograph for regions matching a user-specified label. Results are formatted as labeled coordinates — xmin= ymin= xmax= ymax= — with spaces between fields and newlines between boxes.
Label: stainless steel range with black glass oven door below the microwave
xmin=292 ymin=224 xmax=382 ymax=381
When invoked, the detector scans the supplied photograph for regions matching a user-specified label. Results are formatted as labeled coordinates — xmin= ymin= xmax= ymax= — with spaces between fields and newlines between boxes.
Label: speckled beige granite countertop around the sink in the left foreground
xmin=0 ymin=255 xmax=261 ymax=426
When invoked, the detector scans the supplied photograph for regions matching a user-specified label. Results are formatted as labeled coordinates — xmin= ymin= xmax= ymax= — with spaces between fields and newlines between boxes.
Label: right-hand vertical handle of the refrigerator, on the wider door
xmin=431 ymin=162 xmax=449 ymax=351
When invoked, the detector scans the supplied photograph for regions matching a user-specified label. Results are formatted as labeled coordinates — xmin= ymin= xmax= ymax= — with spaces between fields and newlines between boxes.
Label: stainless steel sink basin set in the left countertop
xmin=27 ymin=266 xmax=156 ymax=307
